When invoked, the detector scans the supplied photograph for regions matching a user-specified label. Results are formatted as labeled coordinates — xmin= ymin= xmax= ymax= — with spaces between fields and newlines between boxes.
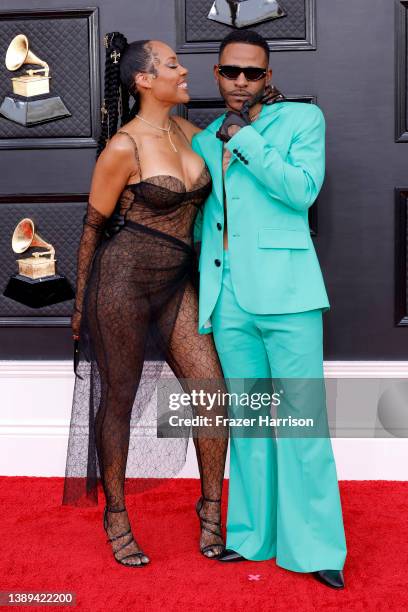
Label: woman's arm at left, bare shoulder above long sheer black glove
xmin=71 ymin=134 xmax=135 ymax=339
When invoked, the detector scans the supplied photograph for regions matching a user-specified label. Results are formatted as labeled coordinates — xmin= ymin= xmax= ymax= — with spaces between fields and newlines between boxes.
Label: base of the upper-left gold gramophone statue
xmin=0 ymin=94 xmax=71 ymax=127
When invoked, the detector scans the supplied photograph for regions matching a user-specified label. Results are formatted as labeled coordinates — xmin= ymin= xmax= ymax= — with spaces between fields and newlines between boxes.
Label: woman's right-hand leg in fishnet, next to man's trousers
xmin=163 ymin=284 xmax=228 ymax=557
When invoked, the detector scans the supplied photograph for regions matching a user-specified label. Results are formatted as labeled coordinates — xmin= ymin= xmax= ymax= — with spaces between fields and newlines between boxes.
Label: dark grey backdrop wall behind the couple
xmin=0 ymin=0 xmax=408 ymax=360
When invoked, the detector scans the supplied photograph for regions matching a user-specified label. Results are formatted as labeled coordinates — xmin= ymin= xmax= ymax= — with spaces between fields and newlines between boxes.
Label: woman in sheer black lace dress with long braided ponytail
xmin=62 ymin=32 xmax=228 ymax=567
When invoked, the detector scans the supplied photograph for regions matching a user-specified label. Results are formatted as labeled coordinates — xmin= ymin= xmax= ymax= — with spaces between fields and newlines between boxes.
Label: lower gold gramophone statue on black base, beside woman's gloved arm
xmin=3 ymin=218 xmax=75 ymax=308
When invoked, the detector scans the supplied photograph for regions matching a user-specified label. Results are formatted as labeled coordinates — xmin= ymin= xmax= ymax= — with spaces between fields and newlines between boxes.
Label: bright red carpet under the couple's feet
xmin=0 ymin=477 xmax=408 ymax=612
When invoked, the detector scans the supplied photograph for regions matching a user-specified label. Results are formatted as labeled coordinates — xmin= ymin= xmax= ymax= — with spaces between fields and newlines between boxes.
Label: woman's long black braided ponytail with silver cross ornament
xmin=96 ymin=32 xmax=155 ymax=159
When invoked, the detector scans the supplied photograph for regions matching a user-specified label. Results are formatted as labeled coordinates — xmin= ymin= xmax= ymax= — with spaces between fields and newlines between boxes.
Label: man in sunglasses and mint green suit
xmin=193 ymin=30 xmax=346 ymax=588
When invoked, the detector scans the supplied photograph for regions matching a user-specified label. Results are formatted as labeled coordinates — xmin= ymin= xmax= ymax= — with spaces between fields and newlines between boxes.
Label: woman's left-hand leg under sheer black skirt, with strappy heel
xmin=88 ymin=266 xmax=149 ymax=565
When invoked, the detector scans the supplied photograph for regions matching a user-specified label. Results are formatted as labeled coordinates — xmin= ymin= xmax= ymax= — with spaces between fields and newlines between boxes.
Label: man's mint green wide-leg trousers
xmin=211 ymin=246 xmax=347 ymax=572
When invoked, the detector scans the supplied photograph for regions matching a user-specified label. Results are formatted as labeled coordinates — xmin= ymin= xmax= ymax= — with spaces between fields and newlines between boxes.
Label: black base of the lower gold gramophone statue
xmin=3 ymin=274 xmax=75 ymax=308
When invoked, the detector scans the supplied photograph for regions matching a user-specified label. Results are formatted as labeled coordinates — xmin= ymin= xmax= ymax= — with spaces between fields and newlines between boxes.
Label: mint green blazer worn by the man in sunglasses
xmin=192 ymin=101 xmax=330 ymax=333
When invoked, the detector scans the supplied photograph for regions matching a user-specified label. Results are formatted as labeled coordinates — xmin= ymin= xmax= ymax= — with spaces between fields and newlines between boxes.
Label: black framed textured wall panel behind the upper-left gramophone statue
xmin=0 ymin=8 xmax=100 ymax=149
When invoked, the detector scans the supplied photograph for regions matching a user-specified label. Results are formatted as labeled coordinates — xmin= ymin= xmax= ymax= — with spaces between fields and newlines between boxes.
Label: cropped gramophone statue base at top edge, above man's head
xmin=208 ymin=0 xmax=287 ymax=28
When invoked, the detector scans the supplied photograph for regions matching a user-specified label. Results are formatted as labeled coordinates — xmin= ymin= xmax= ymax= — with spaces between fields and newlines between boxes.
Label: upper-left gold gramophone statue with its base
xmin=0 ymin=34 xmax=71 ymax=127
